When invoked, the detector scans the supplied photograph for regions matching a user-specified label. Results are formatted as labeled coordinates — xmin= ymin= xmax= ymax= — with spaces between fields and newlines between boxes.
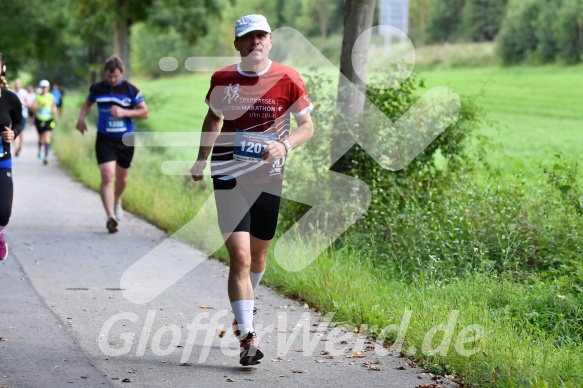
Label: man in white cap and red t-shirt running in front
xmin=191 ymin=15 xmax=314 ymax=365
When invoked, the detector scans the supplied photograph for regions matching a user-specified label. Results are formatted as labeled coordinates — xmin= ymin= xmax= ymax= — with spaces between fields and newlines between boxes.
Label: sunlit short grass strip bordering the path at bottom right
xmin=268 ymin=247 xmax=583 ymax=386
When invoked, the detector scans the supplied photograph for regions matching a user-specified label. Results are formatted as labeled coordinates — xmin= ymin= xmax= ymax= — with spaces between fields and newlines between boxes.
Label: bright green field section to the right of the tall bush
xmin=420 ymin=66 xmax=583 ymax=177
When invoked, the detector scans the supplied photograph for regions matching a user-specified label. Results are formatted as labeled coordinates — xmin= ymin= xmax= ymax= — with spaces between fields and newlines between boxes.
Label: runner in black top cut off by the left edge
xmin=0 ymin=53 xmax=22 ymax=260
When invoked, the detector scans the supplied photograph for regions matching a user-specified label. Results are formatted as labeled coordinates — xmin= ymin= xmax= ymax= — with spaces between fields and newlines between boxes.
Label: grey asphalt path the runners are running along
xmin=0 ymin=131 xmax=452 ymax=388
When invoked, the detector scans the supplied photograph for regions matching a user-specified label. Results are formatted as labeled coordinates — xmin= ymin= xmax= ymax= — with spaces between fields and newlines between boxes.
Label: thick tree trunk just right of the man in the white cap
xmin=331 ymin=0 xmax=376 ymax=172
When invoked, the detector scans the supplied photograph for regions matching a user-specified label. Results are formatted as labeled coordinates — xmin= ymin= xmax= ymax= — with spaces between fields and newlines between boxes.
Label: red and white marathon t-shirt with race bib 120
xmin=205 ymin=61 xmax=312 ymax=183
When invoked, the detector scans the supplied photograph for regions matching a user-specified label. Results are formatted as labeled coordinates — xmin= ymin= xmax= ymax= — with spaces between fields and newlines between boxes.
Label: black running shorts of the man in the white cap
xmin=213 ymin=179 xmax=282 ymax=240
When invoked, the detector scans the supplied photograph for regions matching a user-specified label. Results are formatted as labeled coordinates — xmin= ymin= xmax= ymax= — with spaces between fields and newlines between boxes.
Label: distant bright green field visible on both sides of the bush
xmin=137 ymin=66 xmax=583 ymax=182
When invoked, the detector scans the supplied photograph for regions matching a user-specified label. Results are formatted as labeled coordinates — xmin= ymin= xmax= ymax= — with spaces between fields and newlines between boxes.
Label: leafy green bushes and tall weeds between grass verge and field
xmin=282 ymin=70 xmax=583 ymax=287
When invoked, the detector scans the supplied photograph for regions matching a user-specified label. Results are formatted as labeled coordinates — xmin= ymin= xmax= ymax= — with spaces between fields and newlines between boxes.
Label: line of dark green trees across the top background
xmin=6 ymin=0 xmax=583 ymax=88
